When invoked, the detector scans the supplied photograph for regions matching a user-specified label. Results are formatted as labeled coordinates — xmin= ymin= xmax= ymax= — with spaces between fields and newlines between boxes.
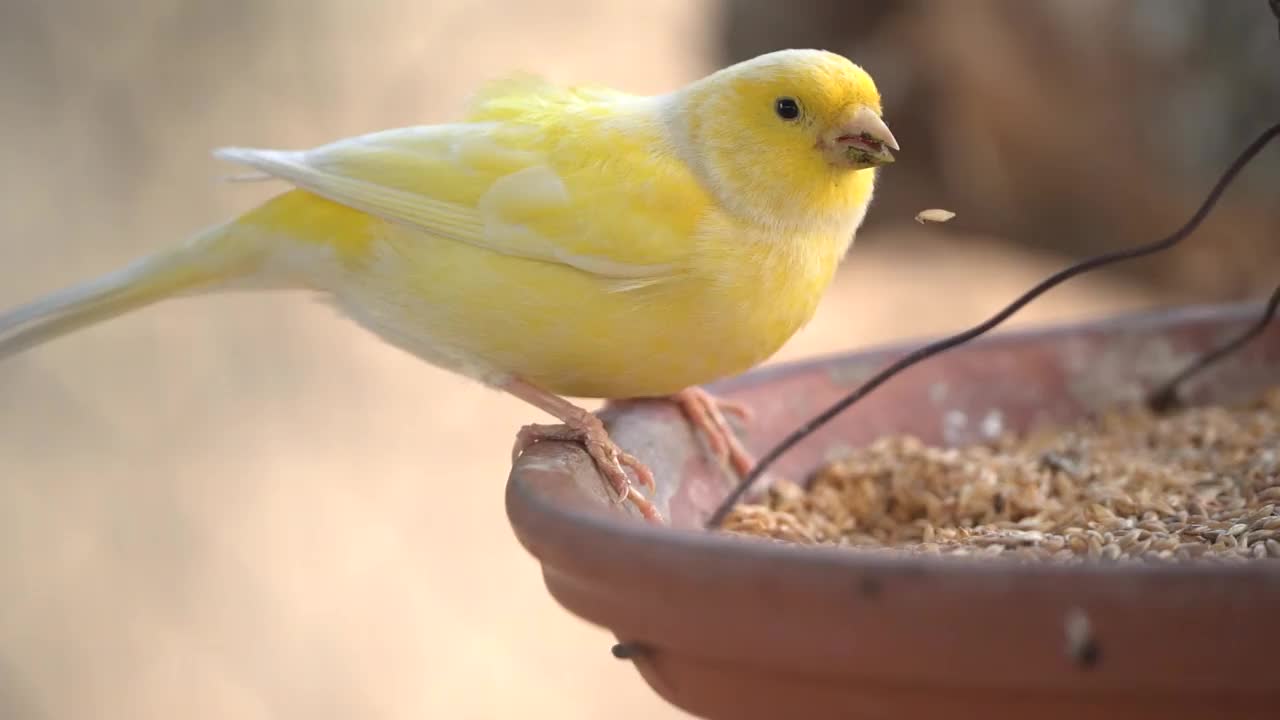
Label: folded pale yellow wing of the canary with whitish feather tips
xmin=216 ymin=103 xmax=696 ymax=280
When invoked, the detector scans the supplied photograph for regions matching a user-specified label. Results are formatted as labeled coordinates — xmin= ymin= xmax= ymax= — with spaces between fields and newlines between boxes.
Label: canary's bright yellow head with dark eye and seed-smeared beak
xmin=677 ymin=50 xmax=899 ymax=228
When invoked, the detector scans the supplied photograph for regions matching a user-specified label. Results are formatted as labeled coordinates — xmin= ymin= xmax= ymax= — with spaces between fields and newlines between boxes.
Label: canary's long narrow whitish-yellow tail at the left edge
xmin=0 ymin=225 xmax=261 ymax=360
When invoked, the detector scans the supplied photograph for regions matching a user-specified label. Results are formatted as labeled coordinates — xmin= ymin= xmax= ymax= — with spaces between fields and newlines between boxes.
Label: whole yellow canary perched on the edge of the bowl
xmin=0 ymin=50 xmax=897 ymax=519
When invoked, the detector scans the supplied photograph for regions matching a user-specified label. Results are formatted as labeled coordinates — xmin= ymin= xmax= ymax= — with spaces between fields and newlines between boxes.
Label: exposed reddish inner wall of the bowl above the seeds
xmin=596 ymin=304 xmax=1280 ymax=528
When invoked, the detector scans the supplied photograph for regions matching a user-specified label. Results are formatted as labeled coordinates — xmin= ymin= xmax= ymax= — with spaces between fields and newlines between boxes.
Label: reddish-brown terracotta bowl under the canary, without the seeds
xmin=507 ymin=299 xmax=1280 ymax=720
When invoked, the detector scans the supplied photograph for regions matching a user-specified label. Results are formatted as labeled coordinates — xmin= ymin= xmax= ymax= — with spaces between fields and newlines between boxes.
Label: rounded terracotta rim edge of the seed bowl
xmin=506 ymin=301 xmax=1280 ymax=587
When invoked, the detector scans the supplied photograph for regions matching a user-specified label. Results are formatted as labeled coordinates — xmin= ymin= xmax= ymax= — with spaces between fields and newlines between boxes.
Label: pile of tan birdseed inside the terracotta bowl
xmin=722 ymin=388 xmax=1280 ymax=562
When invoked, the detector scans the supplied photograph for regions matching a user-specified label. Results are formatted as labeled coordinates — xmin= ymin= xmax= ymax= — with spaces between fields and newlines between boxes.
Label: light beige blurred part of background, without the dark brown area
xmin=0 ymin=0 xmax=1218 ymax=720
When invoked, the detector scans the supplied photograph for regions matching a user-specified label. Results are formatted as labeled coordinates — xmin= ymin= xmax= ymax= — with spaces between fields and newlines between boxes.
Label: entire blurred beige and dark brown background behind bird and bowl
xmin=0 ymin=0 xmax=1280 ymax=720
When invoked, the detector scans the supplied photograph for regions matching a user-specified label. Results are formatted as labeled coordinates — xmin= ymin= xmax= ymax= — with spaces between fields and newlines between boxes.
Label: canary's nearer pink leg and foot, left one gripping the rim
xmin=503 ymin=380 xmax=662 ymax=523
